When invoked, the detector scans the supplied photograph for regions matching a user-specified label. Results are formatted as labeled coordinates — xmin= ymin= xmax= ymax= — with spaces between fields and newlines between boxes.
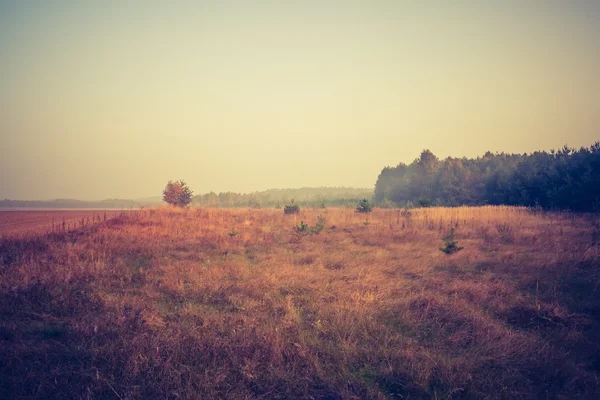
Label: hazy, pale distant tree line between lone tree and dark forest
xmin=192 ymin=187 xmax=373 ymax=208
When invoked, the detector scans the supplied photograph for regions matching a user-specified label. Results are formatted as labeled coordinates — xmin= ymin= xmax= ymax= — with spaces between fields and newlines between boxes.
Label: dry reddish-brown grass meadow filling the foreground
xmin=0 ymin=207 xmax=600 ymax=399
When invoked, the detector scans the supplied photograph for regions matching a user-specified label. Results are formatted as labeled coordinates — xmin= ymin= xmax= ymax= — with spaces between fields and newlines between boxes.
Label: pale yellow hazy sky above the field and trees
xmin=0 ymin=0 xmax=600 ymax=200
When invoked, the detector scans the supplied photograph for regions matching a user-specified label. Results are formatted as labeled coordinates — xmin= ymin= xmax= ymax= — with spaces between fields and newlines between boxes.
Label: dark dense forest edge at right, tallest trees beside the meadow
xmin=374 ymin=142 xmax=600 ymax=211
